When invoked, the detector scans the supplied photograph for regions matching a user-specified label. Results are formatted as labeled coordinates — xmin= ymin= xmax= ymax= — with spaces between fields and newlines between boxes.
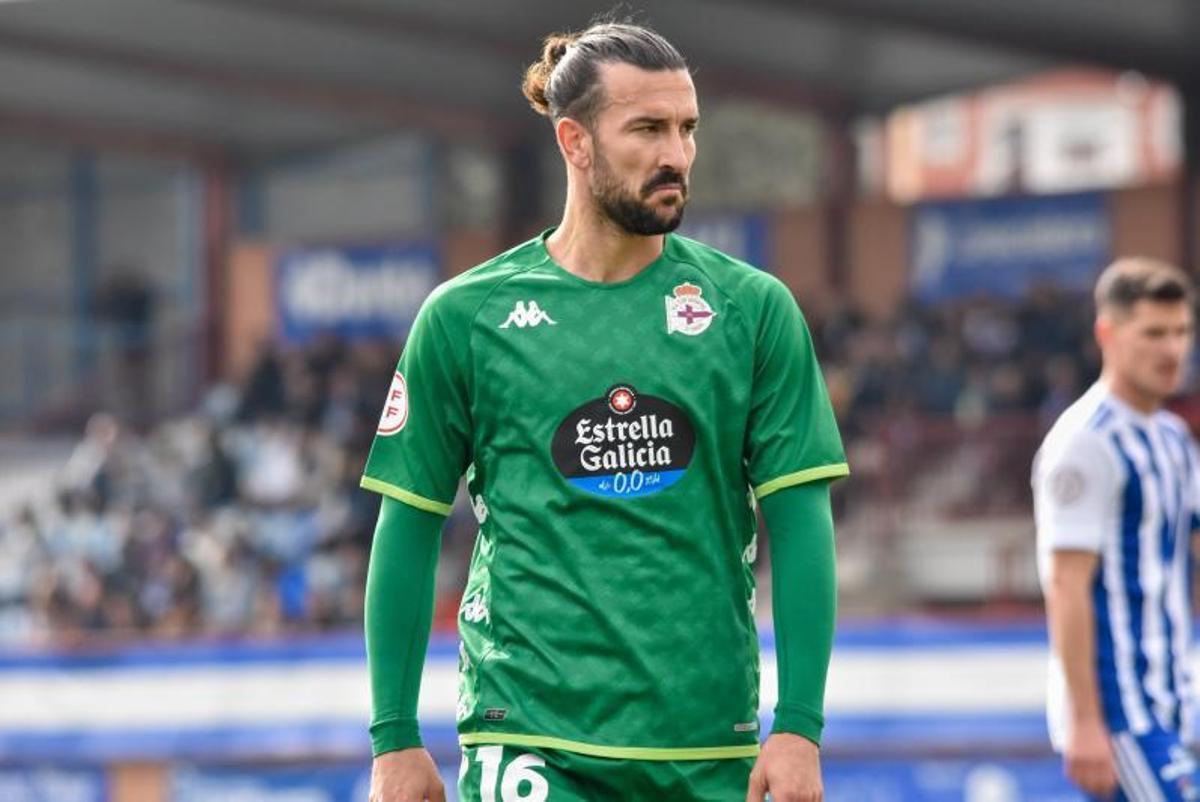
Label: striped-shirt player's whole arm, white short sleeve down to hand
xmin=1033 ymin=430 xmax=1120 ymax=798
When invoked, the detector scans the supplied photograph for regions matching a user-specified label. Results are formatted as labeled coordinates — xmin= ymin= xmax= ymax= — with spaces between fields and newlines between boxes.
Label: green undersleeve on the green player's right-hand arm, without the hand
xmin=761 ymin=481 xmax=838 ymax=744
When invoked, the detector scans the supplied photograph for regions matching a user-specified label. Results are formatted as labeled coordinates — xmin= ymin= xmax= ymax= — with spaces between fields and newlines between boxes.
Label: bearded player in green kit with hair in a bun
xmin=362 ymin=23 xmax=848 ymax=802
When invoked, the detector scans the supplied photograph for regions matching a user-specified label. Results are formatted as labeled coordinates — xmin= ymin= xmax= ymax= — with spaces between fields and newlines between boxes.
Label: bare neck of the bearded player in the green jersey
xmin=546 ymin=204 xmax=664 ymax=283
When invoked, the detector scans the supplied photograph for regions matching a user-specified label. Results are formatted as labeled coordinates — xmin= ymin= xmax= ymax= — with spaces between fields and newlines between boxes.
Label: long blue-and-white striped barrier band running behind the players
xmin=0 ymin=618 xmax=1049 ymax=763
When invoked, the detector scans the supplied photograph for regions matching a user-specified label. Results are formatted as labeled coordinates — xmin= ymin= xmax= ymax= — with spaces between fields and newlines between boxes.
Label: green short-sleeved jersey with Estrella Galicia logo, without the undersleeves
xmin=362 ymin=230 xmax=847 ymax=759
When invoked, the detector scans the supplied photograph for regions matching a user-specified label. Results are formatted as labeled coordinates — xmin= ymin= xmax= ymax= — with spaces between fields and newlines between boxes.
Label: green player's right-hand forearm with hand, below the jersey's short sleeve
xmin=746 ymin=480 xmax=838 ymax=802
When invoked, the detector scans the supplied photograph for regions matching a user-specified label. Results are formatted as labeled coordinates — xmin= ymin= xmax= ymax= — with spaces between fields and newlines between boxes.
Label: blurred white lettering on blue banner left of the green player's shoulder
xmin=282 ymin=251 xmax=436 ymax=325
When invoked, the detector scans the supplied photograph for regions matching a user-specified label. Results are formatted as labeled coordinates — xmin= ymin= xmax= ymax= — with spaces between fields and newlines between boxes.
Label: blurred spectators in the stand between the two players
xmin=812 ymin=285 xmax=1099 ymax=441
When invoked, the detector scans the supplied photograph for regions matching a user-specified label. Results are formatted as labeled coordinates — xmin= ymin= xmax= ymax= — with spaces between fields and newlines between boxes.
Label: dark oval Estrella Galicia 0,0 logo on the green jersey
xmin=551 ymin=383 xmax=696 ymax=498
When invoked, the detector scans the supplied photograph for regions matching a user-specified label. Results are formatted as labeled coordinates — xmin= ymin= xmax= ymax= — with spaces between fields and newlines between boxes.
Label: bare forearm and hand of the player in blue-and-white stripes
xmin=1045 ymin=549 xmax=1117 ymax=797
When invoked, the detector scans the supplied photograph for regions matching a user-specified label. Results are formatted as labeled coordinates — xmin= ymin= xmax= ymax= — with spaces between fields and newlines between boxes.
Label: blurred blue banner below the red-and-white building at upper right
xmin=910 ymin=193 xmax=1110 ymax=301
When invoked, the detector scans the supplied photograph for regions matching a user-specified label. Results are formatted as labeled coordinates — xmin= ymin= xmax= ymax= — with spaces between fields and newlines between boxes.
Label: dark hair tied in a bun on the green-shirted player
xmin=521 ymin=22 xmax=688 ymax=127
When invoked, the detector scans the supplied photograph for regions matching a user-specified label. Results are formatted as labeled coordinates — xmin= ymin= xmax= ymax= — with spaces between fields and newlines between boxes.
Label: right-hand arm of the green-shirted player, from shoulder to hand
xmin=745 ymin=276 xmax=850 ymax=802
